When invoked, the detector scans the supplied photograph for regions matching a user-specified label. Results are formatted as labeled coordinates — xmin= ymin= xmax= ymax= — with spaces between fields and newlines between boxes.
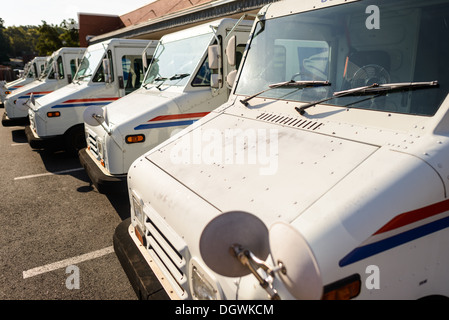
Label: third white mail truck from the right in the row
xmin=25 ymin=39 xmax=157 ymax=155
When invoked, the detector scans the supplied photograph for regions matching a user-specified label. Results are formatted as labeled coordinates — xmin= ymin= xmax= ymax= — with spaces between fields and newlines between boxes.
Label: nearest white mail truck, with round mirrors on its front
xmin=114 ymin=0 xmax=449 ymax=300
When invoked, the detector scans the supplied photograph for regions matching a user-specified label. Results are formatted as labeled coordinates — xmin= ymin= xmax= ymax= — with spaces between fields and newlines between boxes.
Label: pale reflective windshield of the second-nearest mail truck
xmin=143 ymin=33 xmax=213 ymax=87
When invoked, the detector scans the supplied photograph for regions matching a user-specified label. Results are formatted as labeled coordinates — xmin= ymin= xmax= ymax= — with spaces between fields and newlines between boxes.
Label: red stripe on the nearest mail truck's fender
xmin=374 ymin=200 xmax=449 ymax=235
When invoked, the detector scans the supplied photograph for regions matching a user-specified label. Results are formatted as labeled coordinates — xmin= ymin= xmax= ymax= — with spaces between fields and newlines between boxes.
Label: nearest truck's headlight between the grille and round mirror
xmin=189 ymin=259 xmax=221 ymax=300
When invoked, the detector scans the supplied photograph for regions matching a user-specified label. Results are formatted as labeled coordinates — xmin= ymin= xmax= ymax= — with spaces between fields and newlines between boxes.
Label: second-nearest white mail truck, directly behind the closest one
xmin=79 ymin=19 xmax=252 ymax=193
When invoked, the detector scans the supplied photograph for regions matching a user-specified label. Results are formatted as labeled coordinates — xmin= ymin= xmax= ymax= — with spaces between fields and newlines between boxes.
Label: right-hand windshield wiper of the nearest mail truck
xmin=295 ymin=81 xmax=438 ymax=115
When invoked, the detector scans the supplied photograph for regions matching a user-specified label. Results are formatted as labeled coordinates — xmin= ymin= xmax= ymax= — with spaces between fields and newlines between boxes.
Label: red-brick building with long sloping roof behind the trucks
xmin=78 ymin=0 xmax=277 ymax=47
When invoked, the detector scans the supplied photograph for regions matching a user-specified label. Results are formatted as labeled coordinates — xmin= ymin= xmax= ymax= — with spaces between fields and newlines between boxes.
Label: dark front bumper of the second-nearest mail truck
xmin=78 ymin=148 xmax=127 ymax=193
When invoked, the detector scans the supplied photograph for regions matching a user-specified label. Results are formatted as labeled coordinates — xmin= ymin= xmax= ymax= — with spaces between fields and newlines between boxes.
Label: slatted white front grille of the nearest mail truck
xmin=143 ymin=206 xmax=188 ymax=299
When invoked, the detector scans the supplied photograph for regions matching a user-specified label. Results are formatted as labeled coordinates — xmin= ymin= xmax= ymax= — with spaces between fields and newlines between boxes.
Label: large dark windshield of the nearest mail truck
xmin=236 ymin=0 xmax=449 ymax=116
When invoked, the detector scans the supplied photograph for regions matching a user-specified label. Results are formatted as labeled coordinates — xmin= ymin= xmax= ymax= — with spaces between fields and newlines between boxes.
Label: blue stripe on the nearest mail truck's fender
xmin=338 ymin=217 xmax=449 ymax=267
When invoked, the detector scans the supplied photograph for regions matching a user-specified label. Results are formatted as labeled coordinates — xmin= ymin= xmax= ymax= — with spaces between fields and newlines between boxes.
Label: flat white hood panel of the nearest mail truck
xmin=146 ymin=114 xmax=379 ymax=225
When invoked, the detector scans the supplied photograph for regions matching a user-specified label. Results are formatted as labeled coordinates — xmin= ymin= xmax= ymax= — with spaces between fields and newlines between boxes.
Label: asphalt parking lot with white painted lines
xmin=0 ymin=108 xmax=136 ymax=300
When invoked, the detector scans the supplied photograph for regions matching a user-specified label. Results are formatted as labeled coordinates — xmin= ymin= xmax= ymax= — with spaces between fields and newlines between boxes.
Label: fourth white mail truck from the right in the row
xmin=2 ymin=47 xmax=86 ymax=126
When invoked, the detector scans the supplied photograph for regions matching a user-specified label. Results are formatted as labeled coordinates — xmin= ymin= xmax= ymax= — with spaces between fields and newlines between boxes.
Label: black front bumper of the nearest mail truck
xmin=113 ymin=218 xmax=169 ymax=300
